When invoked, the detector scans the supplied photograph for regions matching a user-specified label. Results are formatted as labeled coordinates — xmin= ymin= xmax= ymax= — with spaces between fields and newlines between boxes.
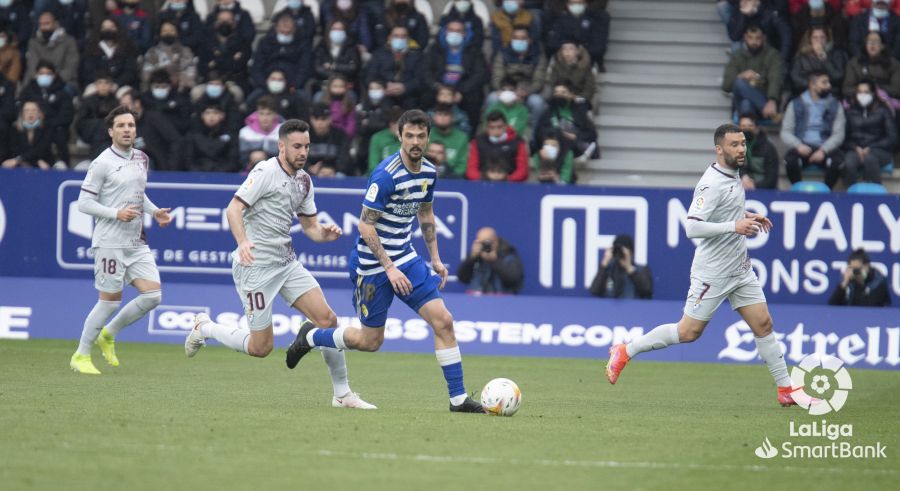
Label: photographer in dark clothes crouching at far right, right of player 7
xmin=828 ymin=249 xmax=891 ymax=307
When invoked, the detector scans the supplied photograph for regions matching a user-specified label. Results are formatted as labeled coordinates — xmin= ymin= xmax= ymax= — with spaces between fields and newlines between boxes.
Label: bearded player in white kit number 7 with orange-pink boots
xmin=606 ymin=124 xmax=801 ymax=406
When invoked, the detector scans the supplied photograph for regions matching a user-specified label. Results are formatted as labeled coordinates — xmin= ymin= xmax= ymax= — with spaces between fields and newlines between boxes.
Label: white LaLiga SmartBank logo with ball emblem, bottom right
xmin=754 ymin=355 xmax=887 ymax=459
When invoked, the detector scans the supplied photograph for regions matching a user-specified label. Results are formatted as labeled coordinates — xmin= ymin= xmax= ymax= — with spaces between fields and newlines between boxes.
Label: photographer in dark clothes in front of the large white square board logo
xmin=590 ymin=234 xmax=653 ymax=298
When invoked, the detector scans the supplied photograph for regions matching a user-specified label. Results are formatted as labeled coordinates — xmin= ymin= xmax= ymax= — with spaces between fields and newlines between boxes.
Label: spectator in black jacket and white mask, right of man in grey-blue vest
xmin=844 ymin=80 xmax=897 ymax=186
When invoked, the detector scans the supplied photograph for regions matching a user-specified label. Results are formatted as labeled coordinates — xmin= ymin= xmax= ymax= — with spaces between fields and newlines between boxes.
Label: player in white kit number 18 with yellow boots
xmin=69 ymin=106 xmax=172 ymax=375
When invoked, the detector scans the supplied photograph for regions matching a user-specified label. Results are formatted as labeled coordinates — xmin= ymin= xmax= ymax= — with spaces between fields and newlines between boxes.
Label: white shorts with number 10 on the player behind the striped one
xmin=231 ymin=261 xmax=319 ymax=331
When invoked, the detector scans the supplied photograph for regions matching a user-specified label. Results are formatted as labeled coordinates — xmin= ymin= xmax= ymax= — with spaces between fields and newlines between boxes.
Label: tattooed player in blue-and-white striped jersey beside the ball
xmin=286 ymin=109 xmax=484 ymax=413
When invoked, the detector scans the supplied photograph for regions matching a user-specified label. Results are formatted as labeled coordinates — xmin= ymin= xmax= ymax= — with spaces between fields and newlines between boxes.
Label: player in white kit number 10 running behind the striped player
xmin=184 ymin=119 xmax=376 ymax=409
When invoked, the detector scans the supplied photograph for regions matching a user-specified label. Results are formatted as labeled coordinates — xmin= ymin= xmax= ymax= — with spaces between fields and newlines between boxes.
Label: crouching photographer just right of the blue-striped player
xmin=456 ymin=227 xmax=525 ymax=295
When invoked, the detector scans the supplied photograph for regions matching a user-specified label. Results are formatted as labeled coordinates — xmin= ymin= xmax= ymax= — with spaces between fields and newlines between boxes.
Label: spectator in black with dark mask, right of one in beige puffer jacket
xmin=197 ymin=9 xmax=251 ymax=94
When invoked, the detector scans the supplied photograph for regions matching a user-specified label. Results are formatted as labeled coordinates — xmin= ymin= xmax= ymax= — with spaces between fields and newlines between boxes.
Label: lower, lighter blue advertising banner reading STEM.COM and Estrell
xmin=0 ymin=278 xmax=900 ymax=370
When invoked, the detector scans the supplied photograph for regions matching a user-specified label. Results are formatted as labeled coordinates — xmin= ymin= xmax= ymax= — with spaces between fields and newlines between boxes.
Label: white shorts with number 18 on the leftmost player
xmin=94 ymin=246 xmax=159 ymax=293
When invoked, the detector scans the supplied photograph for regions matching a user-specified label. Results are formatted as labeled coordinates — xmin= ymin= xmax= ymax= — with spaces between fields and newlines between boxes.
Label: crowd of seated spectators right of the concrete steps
xmin=717 ymin=0 xmax=900 ymax=189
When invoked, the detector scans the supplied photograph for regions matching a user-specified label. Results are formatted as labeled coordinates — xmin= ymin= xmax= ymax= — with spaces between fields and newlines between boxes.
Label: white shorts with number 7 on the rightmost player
xmin=684 ymin=269 xmax=766 ymax=321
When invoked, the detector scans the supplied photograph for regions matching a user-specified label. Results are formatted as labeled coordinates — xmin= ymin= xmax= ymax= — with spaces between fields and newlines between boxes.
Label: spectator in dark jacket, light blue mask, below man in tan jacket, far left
xmin=19 ymin=60 xmax=75 ymax=162
